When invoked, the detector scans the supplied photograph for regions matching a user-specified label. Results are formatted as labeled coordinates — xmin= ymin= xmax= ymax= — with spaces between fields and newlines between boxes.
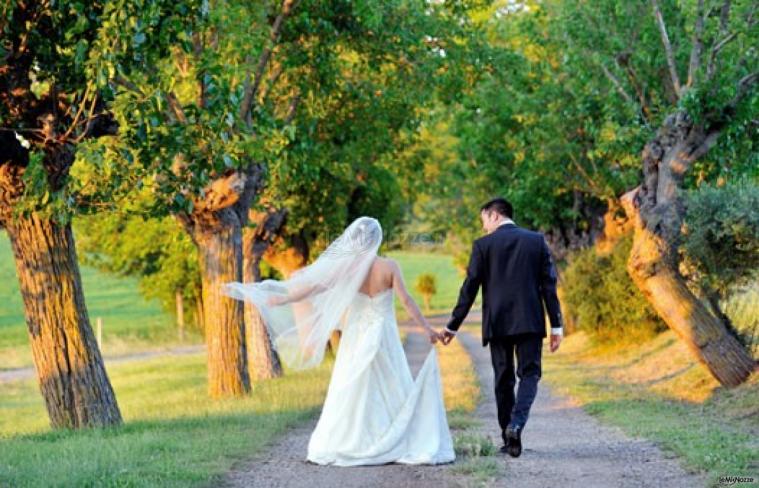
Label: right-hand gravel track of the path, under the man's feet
xmin=459 ymin=333 xmax=706 ymax=488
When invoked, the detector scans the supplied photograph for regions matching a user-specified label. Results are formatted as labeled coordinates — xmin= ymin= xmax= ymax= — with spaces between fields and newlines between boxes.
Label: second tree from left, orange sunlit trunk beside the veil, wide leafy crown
xmin=104 ymin=0 xmax=492 ymax=396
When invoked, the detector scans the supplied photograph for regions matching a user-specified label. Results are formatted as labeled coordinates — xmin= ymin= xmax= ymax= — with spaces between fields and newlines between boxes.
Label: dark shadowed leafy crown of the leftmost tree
xmin=0 ymin=1 xmax=142 ymax=224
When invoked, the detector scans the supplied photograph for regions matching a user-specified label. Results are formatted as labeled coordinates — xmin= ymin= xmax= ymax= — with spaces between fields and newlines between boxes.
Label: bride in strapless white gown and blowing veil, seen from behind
xmin=224 ymin=217 xmax=455 ymax=466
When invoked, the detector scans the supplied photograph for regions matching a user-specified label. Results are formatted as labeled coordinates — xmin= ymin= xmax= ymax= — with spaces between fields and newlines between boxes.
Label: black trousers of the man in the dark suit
xmin=489 ymin=333 xmax=543 ymax=429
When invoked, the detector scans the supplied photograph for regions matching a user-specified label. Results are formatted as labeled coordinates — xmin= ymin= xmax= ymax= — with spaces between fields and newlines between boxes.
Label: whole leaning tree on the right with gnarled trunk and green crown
xmin=418 ymin=0 xmax=759 ymax=385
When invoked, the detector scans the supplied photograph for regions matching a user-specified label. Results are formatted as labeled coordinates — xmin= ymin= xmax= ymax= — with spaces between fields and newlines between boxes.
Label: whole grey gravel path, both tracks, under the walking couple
xmin=225 ymin=311 xmax=706 ymax=488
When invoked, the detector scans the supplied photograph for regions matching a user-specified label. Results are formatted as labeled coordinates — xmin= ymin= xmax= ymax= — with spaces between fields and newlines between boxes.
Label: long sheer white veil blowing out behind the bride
xmin=222 ymin=217 xmax=382 ymax=369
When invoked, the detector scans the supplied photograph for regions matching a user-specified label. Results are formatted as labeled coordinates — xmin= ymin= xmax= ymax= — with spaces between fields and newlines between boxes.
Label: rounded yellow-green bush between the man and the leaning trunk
xmin=562 ymin=237 xmax=667 ymax=342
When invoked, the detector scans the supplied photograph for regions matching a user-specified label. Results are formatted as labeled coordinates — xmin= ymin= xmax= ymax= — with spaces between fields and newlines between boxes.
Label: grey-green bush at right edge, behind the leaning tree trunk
xmin=681 ymin=180 xmax=759 ymax=298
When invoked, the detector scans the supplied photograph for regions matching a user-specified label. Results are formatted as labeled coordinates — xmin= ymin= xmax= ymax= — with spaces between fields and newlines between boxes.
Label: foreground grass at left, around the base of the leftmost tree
xmin=0 ymin=354 xmax=332 ymax=487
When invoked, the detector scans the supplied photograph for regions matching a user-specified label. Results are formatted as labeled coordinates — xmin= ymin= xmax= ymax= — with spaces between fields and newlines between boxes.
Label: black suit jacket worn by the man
xmin=447 ymin=224 xmax=562 ymax=346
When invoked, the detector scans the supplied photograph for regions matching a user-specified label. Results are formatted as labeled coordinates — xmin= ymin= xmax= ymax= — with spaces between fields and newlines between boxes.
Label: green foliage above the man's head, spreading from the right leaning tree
xmin=414 ymin=0 xmax=759 ymax=266
